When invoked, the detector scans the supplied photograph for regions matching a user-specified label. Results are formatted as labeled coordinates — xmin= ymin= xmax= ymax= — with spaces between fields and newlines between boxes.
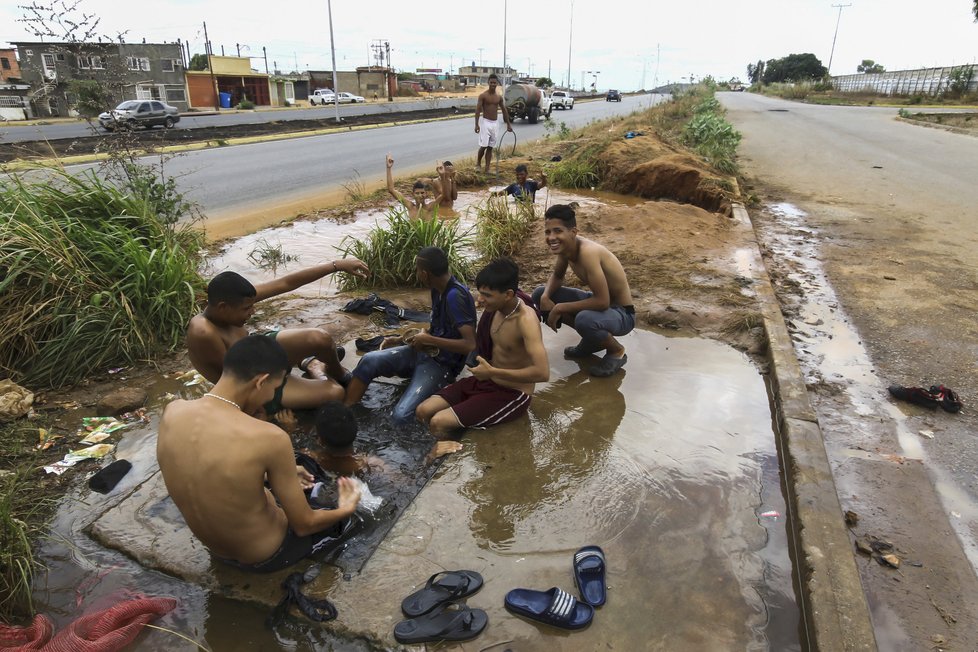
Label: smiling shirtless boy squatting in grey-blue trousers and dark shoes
xmin=533 ymin=204 xmax=635 ymax=376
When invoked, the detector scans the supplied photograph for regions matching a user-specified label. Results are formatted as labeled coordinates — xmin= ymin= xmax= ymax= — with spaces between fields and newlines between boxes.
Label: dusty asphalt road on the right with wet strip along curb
xmin=720 ymin=93 xmax=978 ymax=650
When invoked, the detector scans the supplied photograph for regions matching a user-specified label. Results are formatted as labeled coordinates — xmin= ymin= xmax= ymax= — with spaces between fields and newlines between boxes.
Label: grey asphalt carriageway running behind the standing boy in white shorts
xmin=141 ymin=95 xmax=663 ymax=217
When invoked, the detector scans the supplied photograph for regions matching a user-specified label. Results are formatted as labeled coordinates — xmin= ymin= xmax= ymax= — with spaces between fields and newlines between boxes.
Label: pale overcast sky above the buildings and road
xmin=0 ymin=0 xmax=978 ymax=91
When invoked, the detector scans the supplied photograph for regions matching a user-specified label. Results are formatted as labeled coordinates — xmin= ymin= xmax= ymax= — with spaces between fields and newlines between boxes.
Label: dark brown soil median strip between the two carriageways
xmin=0 ymin=108 xmax=458 ymax=163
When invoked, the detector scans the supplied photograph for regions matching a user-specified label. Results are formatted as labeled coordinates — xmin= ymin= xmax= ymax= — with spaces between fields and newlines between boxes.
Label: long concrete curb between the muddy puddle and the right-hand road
xmin=733 ymin=203 xmax=877 ymax=652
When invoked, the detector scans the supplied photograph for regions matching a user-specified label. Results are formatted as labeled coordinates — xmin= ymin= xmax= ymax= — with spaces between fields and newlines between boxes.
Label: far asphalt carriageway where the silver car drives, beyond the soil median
xmin=0 ymin=97 xmax=475 ymax=143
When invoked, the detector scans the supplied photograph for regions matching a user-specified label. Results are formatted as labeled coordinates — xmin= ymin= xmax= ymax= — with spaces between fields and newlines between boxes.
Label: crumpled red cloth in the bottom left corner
xmin=0 ymin=598 xmax=177 ymax=652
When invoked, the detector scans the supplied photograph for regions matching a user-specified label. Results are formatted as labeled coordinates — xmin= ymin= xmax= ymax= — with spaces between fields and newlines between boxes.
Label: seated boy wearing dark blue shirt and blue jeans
xmin=344 ymin=247 xmax=476 ymax=424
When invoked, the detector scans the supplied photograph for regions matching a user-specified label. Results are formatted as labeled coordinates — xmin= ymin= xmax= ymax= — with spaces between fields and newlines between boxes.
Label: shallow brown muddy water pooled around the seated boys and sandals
xmin=35 ymin=193 xmax=800 ymax=650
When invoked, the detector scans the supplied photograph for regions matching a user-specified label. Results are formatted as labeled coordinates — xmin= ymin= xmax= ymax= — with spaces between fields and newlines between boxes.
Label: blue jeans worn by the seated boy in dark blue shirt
xmin=353 ymin=346 xmax=455 ymax=424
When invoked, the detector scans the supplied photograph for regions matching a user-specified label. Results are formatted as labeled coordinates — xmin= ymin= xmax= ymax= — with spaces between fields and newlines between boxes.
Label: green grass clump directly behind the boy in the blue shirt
xmin=337 ymin=205 xmax=472 ymax=292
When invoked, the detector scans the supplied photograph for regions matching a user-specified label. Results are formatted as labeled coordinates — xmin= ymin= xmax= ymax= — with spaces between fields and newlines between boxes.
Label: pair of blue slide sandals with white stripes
xmin=506 ymin=546 xmax=608 ymax=629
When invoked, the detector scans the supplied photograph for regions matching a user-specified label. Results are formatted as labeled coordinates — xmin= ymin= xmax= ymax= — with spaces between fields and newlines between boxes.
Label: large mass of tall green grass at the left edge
xmin=0 ymin=172 xmax=203 ymax=389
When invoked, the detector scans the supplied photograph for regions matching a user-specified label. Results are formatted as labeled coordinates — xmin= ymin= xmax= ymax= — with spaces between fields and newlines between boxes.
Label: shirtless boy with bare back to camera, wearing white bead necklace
xmin=156 ymin=335 xmax=360 ymax=572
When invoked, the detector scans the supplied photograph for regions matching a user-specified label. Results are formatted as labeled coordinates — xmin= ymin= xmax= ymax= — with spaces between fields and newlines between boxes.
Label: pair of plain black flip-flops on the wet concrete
xmin=394 ymin=570 xmax=489 ymax=644
